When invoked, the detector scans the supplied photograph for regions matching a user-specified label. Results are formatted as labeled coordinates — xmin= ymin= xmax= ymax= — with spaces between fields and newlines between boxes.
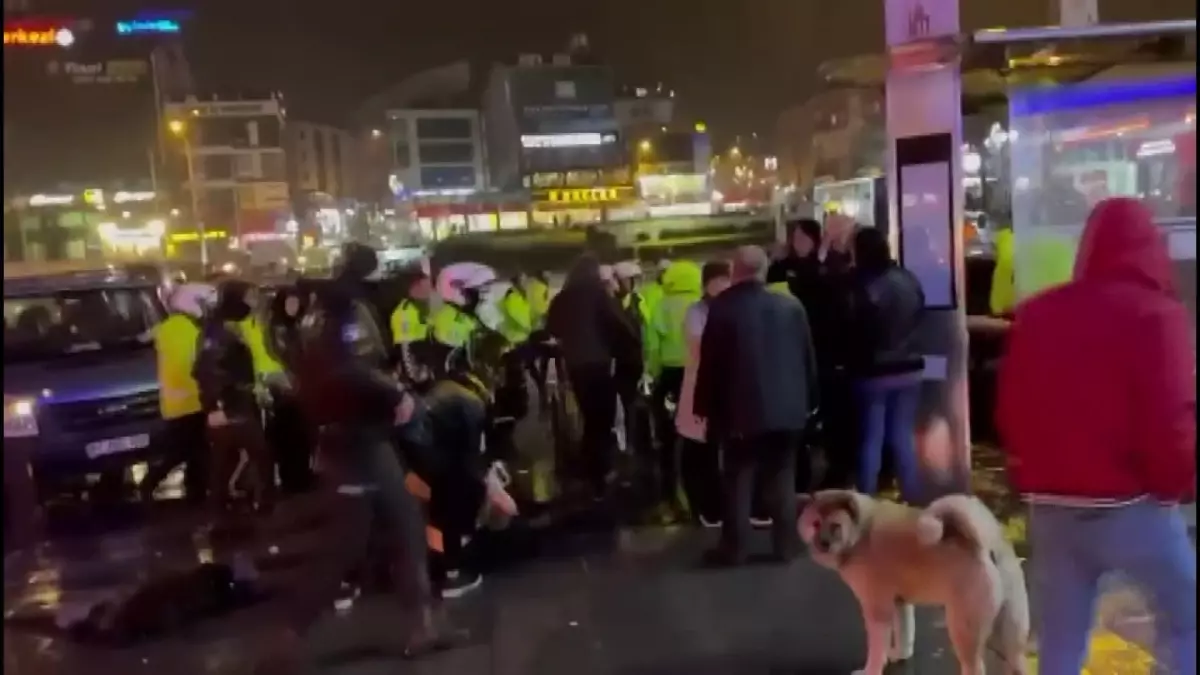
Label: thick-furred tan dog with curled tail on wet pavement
xmin=798 ymin=490 xmax=1030 ymax=675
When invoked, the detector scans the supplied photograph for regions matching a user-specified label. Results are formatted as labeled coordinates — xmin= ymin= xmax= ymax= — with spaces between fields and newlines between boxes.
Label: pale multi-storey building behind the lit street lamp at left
xmin=164 ymin=94 xmax=292 ymax=241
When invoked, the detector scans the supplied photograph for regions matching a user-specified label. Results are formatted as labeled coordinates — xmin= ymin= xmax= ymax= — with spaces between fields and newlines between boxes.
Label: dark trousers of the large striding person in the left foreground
xmin=286 ymin=425 xmax=432 ymax=632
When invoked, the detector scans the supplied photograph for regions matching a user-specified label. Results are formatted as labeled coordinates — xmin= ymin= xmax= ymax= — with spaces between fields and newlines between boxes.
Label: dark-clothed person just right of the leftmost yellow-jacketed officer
xmin=192 ymin=281 xmax=275 ymax=510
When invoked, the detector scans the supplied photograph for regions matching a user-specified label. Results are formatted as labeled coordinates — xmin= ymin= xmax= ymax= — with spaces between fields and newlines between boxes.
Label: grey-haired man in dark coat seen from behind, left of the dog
xmin=694 ymin=246 xmax=818 ymax=566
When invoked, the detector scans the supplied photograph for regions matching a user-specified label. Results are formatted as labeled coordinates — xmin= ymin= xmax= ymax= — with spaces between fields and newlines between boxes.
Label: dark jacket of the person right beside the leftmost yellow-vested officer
xmin=192 ymin=318 xmax=258 ymax=418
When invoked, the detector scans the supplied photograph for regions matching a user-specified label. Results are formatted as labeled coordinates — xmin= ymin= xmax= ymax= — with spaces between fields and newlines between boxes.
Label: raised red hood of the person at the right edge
xmin=1074 ymin=197 xmax=1175 ymax=294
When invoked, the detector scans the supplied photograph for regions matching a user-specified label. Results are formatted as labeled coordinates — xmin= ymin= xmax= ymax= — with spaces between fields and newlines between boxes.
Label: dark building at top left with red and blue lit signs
xmin=4 ymin=14 xmax=192 ymax=193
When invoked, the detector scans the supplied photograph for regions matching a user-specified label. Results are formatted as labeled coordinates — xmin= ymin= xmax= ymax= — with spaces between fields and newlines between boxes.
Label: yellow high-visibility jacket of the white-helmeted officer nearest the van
xmin=154 ymin=312 xmax=200 ymax=419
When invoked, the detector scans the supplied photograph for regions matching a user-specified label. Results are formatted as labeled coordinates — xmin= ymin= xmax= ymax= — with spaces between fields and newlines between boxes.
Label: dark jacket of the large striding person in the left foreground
xmin=296 ymin=271 xmax=403 ymax=425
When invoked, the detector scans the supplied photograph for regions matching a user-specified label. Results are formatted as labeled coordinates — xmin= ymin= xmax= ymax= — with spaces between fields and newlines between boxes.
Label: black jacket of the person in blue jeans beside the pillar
xmin=847 ymin=264 xmax=925 ymax=377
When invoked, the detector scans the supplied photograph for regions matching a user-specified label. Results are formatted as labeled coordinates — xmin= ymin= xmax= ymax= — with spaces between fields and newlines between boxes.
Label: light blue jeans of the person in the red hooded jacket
xmin=1028 ymin=500 xmax=1196 ymax=675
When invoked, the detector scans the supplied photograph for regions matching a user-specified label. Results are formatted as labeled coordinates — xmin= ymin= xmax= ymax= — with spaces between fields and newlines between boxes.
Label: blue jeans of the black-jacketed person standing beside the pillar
xmin=856 ymin=374 xmax=920 ymax=502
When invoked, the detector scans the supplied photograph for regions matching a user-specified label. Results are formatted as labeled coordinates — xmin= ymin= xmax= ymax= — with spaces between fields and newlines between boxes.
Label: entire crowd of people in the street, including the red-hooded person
xmin=93 ymin=193 xmax=1195 ymax=673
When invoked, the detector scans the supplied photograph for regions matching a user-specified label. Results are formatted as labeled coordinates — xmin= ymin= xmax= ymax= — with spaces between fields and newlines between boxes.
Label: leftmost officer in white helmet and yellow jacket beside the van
xmin=138 ymin=283 xmax=217 ymax=503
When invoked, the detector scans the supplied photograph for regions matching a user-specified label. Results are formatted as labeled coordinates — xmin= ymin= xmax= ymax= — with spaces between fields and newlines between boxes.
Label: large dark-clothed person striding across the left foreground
xmin=259 ymin=243 xmax=460 ymax=667
